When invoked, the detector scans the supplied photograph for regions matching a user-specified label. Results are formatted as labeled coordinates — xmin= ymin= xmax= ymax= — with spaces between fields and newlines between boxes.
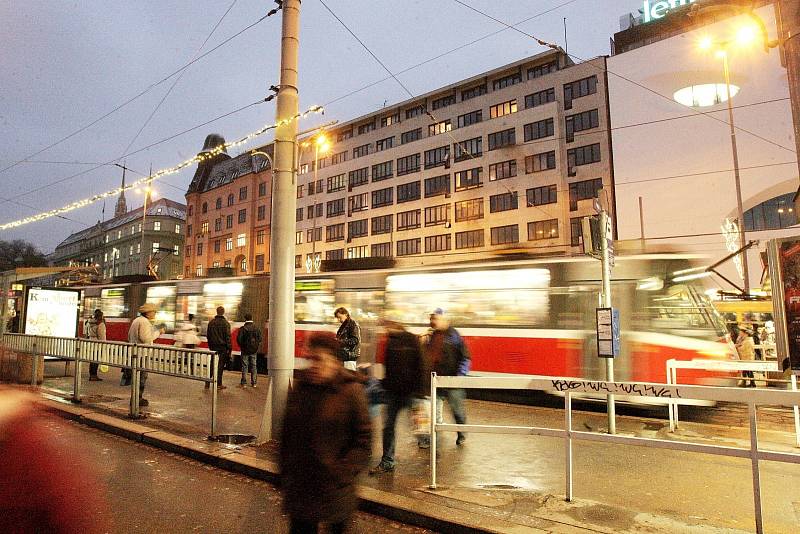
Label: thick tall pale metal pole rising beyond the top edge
xmin=265 ymin=0 xmax=300 ymax=440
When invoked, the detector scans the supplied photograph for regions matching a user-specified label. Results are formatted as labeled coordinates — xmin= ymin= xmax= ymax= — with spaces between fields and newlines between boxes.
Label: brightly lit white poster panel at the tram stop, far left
xmin=25 ymin=287 xmax=81 ymax=337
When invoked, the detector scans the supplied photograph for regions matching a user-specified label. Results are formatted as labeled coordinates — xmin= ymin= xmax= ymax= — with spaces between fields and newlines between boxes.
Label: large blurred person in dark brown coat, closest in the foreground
xmin=280 ymin=332 xmax=372 ymax=534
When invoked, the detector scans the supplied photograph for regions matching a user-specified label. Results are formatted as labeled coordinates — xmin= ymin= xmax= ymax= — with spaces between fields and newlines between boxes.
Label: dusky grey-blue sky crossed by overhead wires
xmin=0 ymin=0 xmax=640 ymax=253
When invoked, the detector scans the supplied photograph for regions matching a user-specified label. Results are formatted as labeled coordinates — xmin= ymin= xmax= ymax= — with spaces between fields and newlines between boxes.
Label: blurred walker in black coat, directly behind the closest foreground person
xmin=369 ymin=320 xmax=430 ymax=475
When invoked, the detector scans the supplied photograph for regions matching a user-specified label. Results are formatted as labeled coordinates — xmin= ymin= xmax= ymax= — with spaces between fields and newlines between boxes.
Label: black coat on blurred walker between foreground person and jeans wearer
xmin=383 ymin=331 xmax=430 ymax=397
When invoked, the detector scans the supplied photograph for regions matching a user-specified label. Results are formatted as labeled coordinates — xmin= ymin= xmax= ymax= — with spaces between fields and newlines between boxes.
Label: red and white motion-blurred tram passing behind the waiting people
xmin=72 ymin=254 xmax=734 ymax=383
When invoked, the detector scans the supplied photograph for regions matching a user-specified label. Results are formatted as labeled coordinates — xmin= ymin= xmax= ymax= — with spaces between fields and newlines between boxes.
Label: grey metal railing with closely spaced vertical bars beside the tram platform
xmin=3 ymin=334 xmax=219 ymax=436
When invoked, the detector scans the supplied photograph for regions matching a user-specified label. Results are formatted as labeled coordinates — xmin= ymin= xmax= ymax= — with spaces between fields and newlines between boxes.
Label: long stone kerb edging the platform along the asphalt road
xmin=38 ymin=399 xmax=547 ymax=534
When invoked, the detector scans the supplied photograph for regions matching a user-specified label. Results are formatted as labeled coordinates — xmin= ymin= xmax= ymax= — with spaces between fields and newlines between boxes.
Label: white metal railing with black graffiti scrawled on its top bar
xmin=430 ymin=373 xmax=800 ymax=534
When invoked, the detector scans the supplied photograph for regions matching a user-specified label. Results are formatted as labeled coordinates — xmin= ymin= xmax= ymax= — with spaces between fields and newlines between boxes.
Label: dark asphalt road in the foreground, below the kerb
xmin=40 ymin=418 xmax=429 ymax=534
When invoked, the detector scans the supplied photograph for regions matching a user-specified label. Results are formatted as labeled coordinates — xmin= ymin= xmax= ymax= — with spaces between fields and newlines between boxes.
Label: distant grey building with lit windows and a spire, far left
xmin=50 ymin=197 xmax=186 ymax=279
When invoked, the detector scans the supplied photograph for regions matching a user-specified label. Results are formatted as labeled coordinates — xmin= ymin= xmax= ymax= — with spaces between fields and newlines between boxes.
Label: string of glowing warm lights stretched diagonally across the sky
xmin=0 ymin=106 xmax=324 ymax=230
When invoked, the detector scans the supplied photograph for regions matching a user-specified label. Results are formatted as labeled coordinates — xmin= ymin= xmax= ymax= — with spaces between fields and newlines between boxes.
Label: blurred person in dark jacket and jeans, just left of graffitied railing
xmin=425 ymin=308 xmax=471 ymax=445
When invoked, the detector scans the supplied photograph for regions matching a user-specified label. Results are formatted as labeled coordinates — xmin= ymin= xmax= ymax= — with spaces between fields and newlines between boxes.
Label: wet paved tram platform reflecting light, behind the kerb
xmin=36 ymin=367 xmax=800 ymax=532
